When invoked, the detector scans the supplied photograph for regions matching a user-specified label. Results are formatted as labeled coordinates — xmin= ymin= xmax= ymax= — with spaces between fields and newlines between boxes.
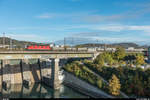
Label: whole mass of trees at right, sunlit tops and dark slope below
xmin=84 ymin=48 xmax=150 ymax=97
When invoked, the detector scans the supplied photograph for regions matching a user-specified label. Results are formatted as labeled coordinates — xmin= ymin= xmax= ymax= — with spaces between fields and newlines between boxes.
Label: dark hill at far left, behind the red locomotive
xmin=0 ymin=37 xmax=45 ymax=47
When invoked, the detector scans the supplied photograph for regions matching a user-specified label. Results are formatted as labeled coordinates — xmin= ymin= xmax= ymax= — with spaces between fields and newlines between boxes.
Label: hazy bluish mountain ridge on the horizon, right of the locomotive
xmin=55 ymin=38 xmax=148 ymax=48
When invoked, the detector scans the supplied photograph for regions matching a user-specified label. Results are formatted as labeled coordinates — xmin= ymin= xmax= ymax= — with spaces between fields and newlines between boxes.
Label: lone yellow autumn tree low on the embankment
xmin=108 ymin=74 xmax=121 ymax=96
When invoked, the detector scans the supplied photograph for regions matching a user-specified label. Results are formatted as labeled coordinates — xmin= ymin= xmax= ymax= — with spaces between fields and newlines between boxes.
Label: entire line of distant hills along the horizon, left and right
xmin=0 ymin=37 xmax=148 ymax=48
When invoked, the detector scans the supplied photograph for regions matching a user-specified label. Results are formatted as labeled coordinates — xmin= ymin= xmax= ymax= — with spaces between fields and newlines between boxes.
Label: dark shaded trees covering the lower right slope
xmin=86 ymin=62 xmax=150 ymax=97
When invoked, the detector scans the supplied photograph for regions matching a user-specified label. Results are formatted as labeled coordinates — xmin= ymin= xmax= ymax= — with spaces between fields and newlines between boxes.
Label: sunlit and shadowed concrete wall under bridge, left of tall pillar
xmin=0 ymin=59 xmax=52 ymax=89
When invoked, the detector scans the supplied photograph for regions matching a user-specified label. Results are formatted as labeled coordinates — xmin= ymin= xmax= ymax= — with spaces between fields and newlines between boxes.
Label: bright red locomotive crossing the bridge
xmin=27 ymin=45 xmax=51 ymax=50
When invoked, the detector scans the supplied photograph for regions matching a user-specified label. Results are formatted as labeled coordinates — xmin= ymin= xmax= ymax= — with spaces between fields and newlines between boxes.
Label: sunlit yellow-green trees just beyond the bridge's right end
xmin=93 ymin=48 xmax=146 ymax=67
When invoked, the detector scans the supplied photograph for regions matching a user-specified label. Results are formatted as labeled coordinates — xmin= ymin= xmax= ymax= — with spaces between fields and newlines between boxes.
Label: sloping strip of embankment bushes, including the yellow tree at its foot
xmin=64 ymin=61 xmax=122 ymax=97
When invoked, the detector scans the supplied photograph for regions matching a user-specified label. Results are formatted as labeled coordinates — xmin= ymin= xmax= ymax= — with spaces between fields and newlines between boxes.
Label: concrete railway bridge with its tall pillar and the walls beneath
xmin=0 ymin=51 xmax=97 ymax=89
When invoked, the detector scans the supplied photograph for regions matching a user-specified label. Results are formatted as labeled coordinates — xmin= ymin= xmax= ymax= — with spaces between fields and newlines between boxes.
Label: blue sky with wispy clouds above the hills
xmin=0 ymin=0 xmax=150 ymax=43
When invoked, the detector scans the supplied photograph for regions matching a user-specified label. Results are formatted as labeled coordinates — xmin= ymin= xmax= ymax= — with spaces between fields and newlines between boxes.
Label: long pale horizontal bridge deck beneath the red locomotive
xmin=0 ymin=51 xmax=94 ymax=59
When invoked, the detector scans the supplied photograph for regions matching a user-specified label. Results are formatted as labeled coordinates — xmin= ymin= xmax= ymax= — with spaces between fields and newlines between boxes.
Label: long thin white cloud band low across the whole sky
xmin=8 ymin=24 xmax=150 ymax=32
